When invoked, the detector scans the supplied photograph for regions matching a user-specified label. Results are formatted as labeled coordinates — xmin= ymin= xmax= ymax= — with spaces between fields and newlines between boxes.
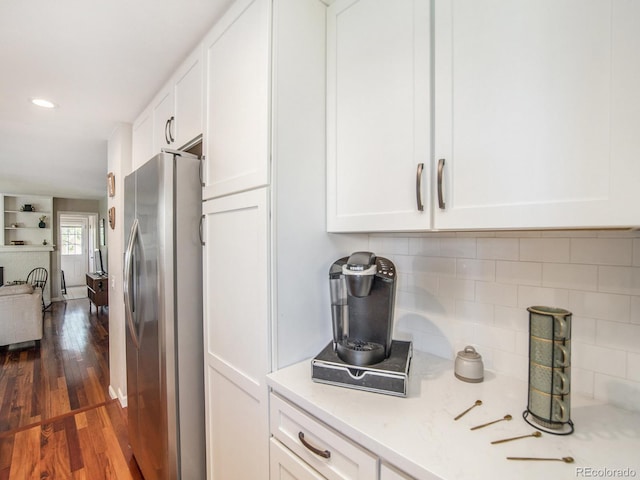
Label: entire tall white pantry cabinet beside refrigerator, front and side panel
xmin=203 ymin=0 xmax=366 ymax=480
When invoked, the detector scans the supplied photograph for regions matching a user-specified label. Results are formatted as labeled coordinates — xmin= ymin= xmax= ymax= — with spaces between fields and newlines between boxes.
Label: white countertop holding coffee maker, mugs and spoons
xmin=268 ymin=352 xmax=640 ymax=480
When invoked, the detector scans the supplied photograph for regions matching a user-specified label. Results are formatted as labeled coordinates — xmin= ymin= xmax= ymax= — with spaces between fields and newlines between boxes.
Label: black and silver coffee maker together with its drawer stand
xmin=312 ymin=252 xmax=412 ymax=396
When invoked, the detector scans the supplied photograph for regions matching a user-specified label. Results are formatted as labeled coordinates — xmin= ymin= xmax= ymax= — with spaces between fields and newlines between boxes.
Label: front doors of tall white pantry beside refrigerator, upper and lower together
xmin=203 ymin=0 xmax=271 ymax=479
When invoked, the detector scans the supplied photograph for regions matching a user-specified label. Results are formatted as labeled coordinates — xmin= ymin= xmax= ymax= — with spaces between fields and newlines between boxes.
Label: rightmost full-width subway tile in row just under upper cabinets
xmin=571 ymin=238 xmax=632 ymax=266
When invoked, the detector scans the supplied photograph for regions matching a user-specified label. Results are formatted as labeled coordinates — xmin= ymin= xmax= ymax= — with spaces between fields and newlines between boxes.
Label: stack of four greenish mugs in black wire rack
xmin=522 ymin=306 xmax=573 ymax=435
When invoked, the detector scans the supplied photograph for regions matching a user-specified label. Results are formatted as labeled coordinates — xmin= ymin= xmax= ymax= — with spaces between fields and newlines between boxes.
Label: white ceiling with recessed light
xmin=0 ymin=0 xmax=232 ymax=199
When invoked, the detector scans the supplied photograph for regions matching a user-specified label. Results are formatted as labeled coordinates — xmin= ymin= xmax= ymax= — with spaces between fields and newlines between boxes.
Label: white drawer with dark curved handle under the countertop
xmin=270 ymin=394 xmax=378 ymax=480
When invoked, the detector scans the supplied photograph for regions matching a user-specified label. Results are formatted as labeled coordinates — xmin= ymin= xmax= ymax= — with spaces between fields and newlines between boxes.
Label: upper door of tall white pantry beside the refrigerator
xmin=203 ymin=0 xmax=270 ymax=198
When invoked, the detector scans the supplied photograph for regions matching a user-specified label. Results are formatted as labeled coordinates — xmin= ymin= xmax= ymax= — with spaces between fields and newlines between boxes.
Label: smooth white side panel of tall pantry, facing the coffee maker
xmin=272 ymin=0 xmax=368 ymax=369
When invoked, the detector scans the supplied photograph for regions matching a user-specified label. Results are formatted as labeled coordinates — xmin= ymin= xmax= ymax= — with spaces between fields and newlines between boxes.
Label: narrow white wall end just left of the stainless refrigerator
xmin=105 ymin=123 xmax=132 ymax=407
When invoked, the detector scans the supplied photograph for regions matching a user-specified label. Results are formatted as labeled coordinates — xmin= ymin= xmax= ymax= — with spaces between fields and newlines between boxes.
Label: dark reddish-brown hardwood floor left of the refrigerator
xmin=0 ymin=299 xmax=142 ymax=480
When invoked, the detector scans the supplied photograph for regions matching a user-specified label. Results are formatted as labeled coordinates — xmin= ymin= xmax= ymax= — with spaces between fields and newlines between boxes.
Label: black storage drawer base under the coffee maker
xmin=311 ymin=340 xmax=413 ymax=397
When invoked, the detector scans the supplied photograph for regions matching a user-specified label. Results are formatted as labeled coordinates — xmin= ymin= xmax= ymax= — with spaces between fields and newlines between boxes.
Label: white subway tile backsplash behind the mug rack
xmin=369 ymin=231 xmax=640 ymax=411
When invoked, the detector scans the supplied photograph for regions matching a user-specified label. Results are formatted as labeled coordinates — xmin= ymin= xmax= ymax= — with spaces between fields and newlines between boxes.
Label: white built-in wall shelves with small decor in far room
xmin=0 ymin=194 xmax=53 ymax=251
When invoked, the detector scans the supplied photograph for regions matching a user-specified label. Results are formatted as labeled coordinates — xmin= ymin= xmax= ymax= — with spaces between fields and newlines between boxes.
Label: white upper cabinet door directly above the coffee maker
xmin=327 ymin=0 xmax=431 ymax=232
